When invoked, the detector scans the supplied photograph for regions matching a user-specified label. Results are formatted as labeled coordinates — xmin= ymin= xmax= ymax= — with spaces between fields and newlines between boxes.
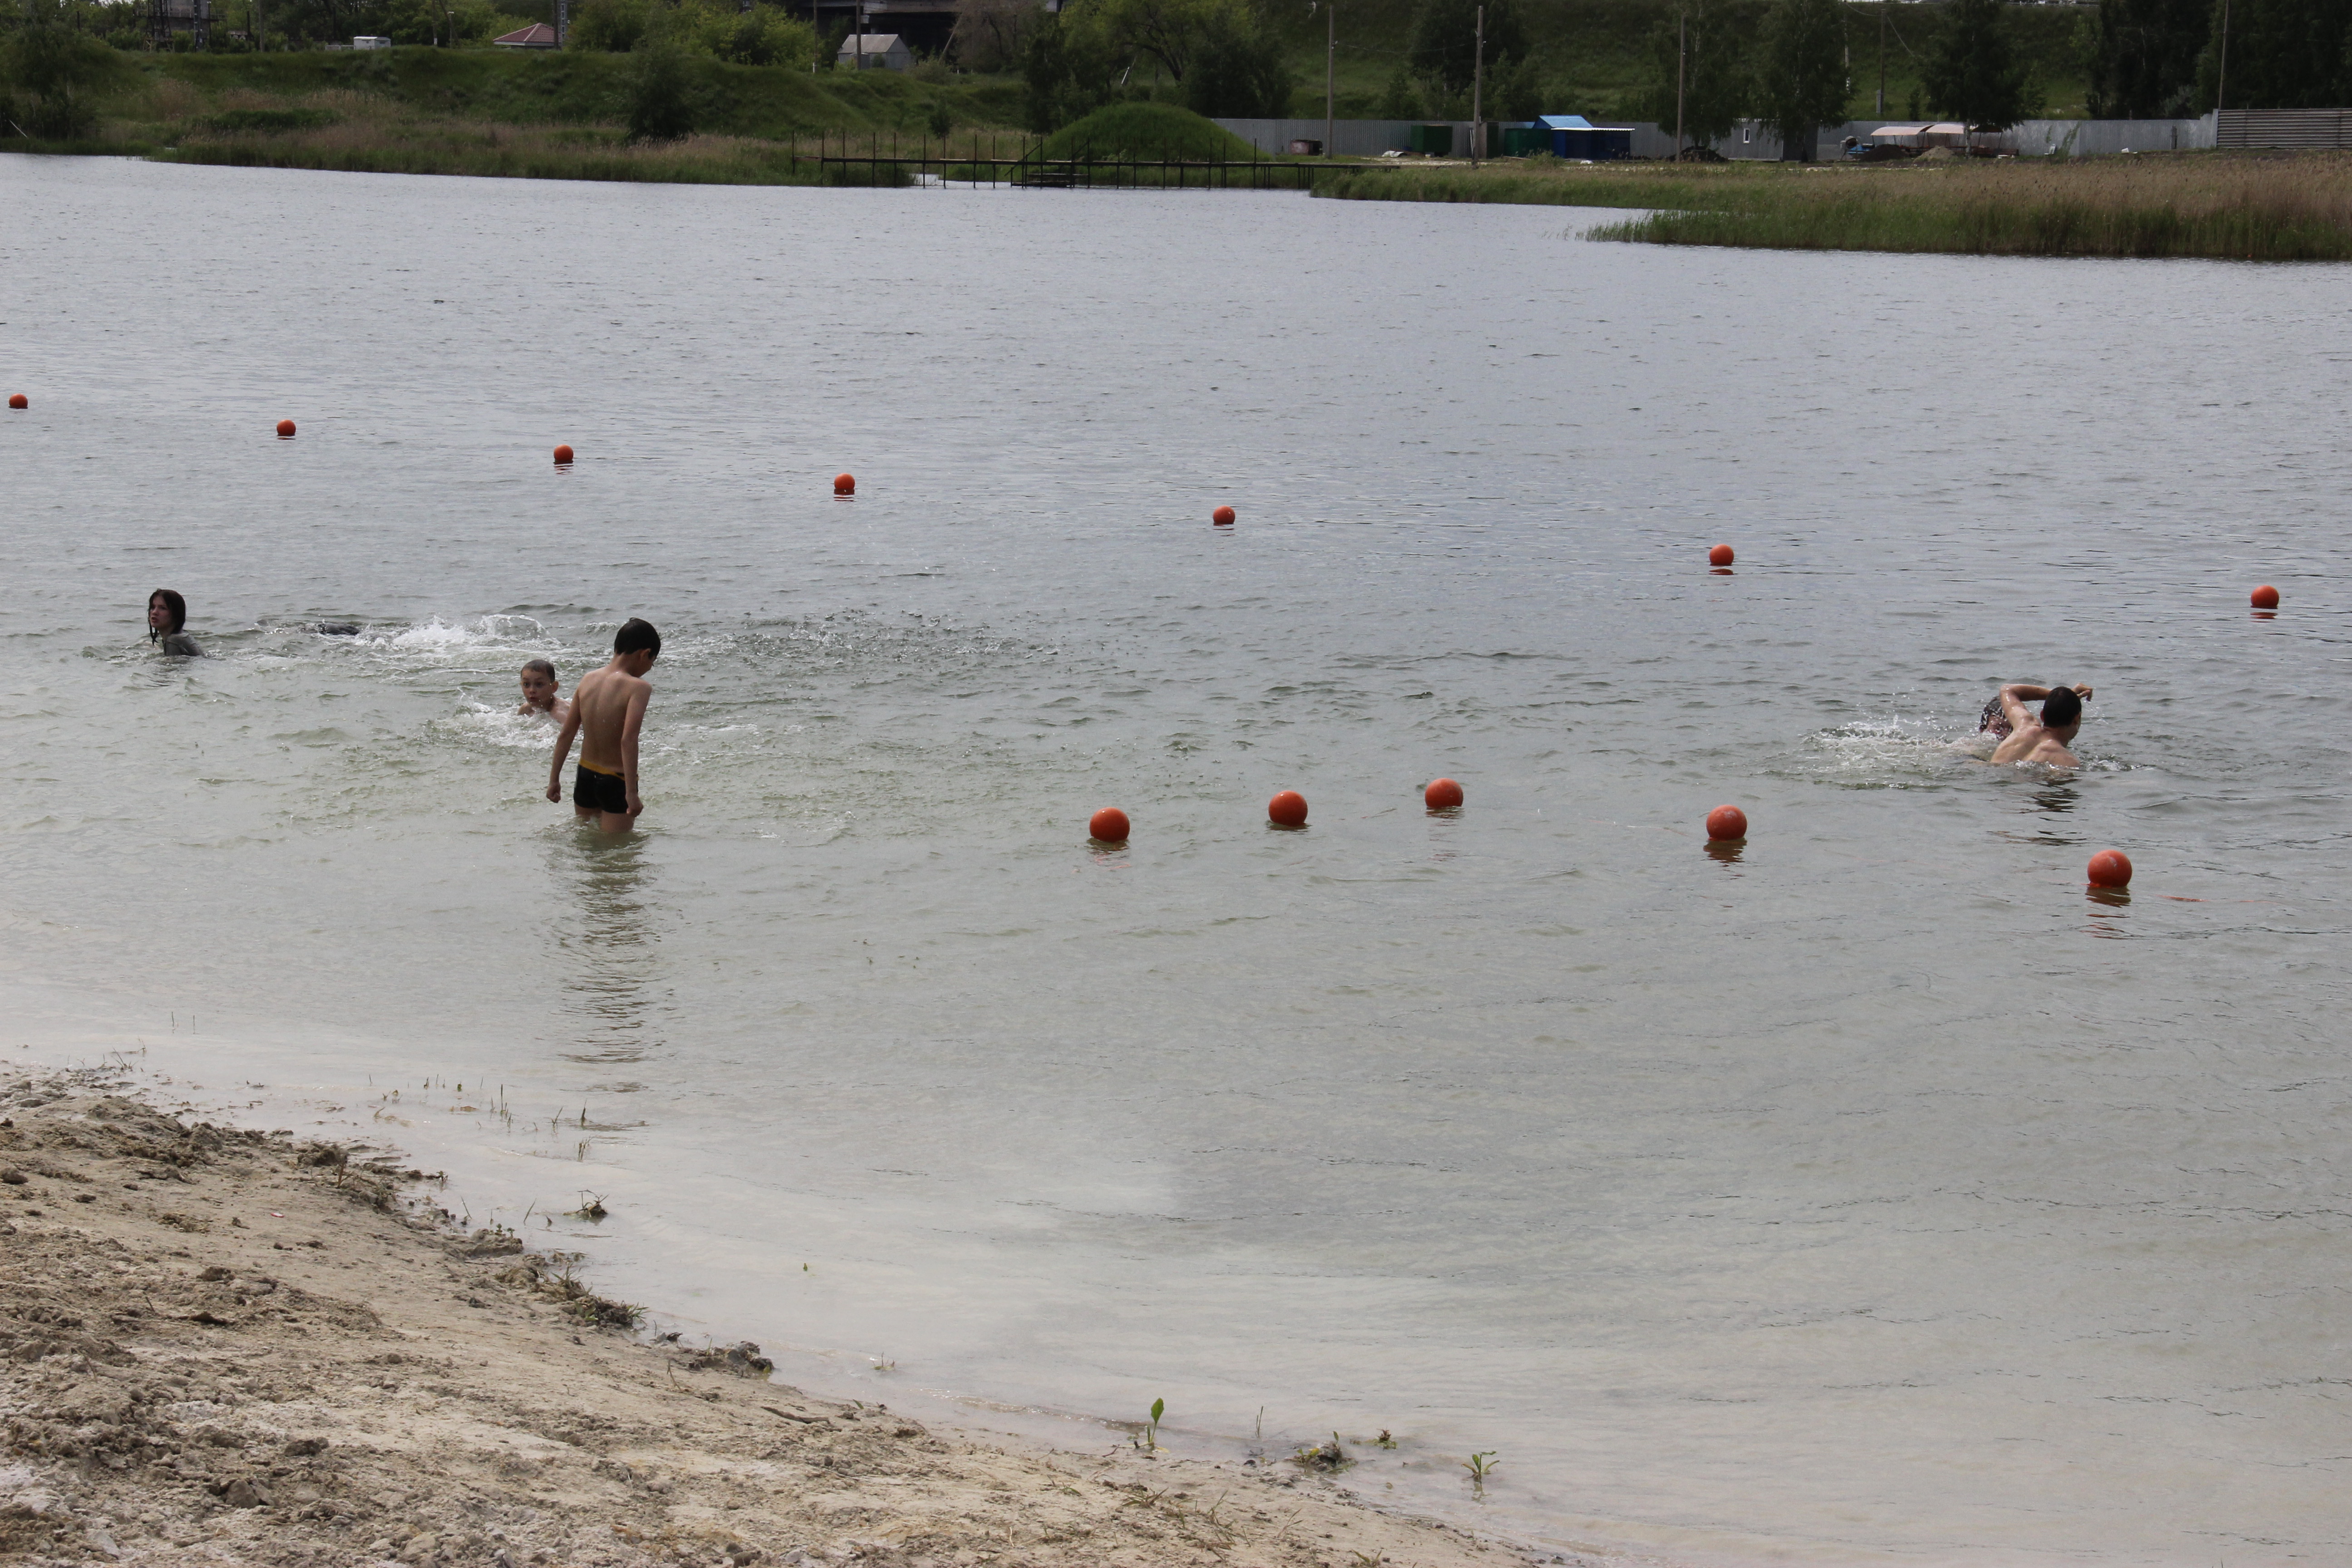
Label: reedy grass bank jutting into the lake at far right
xmin=1315 ymin=153 xmax=2352 ymax=261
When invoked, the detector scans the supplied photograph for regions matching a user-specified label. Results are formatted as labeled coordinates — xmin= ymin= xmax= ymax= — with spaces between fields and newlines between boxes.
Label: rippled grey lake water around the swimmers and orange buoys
xmin=0 ymin=157 xmax=2352 ymax=1568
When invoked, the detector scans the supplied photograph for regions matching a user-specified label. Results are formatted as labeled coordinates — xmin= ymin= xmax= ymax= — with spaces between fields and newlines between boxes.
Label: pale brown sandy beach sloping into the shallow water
xmin=0 ymin=1072 xmax=1599 ymax=1568
